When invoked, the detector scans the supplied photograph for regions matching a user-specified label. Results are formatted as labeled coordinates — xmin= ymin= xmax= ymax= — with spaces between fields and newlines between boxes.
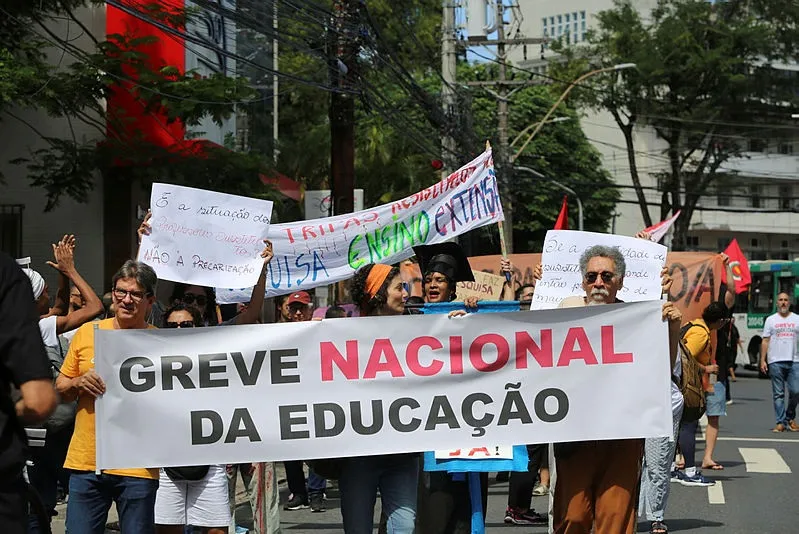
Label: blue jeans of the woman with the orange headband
xmin=338 ymin=454 xmax=419 ymax=534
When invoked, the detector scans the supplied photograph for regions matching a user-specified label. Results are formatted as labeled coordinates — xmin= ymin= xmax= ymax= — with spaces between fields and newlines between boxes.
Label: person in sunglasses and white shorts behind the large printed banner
xmin=155 ymin=303 xmax=230 ymax=534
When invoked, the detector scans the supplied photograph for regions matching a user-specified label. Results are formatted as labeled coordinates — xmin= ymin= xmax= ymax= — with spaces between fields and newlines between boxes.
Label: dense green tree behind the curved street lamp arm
xmin=458 ymin=64 xmax=619 ymax=251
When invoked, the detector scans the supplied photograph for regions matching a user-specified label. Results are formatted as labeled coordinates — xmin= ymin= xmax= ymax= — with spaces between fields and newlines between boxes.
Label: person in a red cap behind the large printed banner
xmin=283 ymin=291 xmax=328 ymax=512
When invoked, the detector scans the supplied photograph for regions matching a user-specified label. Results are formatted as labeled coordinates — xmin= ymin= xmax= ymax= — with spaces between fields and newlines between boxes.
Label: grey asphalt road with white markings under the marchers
xmin=54 ymin=371 xmax=799 ymax=534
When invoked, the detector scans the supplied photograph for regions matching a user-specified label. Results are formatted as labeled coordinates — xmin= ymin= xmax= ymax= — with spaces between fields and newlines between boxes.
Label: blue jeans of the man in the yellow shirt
xmin=67 ymin=471 xmax=158 ymax=534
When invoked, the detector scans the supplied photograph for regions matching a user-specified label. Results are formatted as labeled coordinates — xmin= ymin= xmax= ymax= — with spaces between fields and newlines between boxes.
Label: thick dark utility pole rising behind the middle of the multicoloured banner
xmin=329 ymin=0 xmax=358 ymax=215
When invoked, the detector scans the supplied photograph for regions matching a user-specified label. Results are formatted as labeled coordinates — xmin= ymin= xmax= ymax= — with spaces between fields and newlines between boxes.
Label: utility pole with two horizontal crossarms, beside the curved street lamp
xmin=467 ymin=0 xmax=545 ymax=254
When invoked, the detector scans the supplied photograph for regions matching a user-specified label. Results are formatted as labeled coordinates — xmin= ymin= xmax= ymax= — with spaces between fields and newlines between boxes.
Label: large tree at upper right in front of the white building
xmin=551 ymin=0 xmax=799 ymax=250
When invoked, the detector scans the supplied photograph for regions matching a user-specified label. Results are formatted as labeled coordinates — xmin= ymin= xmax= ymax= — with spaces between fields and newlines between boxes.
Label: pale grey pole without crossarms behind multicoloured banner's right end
xmin=441 ymin=0 xmax=459 ymax=177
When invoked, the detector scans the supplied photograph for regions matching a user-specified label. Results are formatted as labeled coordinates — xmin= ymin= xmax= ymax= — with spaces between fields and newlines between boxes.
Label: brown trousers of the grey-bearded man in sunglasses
xmin=553 ymin=439 xmax=644 ymax=534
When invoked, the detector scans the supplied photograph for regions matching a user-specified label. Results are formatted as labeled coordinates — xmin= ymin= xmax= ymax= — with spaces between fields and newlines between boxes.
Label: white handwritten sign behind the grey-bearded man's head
xmin=531 ymin=230 xmax=667 ymax=310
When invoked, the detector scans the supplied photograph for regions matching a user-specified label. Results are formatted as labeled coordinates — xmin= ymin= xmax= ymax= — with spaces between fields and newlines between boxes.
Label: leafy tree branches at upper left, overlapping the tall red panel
xmin=0 ymin=0 xmax=282 ymax=214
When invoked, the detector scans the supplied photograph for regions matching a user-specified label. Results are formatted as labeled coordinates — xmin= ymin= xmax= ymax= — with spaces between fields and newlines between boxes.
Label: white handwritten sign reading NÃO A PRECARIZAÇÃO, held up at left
xmin=138 ymin=183 xmax=272 ymax=288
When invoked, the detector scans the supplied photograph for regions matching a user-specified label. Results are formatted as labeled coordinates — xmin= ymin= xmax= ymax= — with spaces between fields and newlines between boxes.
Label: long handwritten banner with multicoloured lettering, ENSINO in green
xmin=266 ymin=150 xmax=505 ymax=296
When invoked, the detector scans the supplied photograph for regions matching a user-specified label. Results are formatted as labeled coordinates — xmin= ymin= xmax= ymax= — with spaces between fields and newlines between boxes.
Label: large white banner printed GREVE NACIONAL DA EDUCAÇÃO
xmin=95 ymin=302 xmax=671 ymax=469
